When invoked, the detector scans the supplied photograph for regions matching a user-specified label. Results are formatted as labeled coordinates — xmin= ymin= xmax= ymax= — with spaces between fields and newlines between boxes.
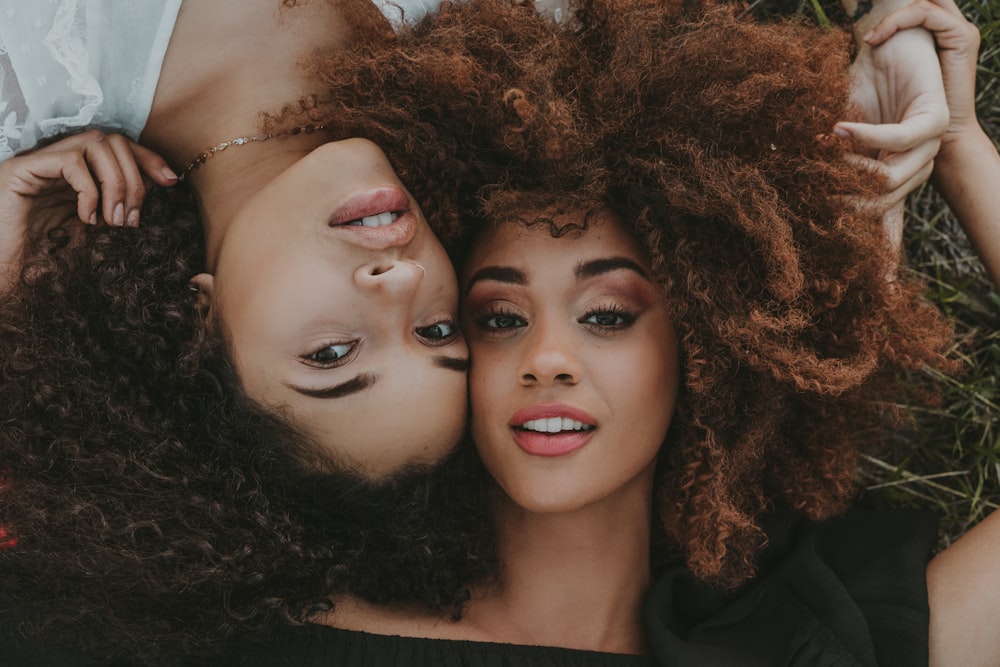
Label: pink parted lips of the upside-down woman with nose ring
xmin=328 ymin=186 xmax=417 ymax=250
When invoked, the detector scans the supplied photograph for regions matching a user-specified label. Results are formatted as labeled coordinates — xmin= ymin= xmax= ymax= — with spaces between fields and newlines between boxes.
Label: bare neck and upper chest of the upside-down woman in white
xmin=141 ymin=0 xmax=364 ymax=266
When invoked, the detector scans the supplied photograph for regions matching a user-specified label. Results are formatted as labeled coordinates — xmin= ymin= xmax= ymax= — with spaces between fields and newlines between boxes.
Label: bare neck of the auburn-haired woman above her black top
xmin=468 ymin=469 xmax=652 ymax=654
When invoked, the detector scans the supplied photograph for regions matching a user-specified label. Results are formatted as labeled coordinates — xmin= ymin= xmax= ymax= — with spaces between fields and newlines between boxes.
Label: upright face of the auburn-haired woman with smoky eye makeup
xmin=462 ymin=213 xmax=679 ymax=512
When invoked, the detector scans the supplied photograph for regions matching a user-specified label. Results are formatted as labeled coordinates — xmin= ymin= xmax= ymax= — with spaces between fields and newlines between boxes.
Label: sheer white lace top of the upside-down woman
xmin=0 ymin=0 xmax=566 ymax=162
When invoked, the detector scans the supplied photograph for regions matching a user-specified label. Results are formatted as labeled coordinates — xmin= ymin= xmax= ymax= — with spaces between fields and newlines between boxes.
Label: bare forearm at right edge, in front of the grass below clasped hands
xmin=933 ymin=125 xmax=1000 ymax=290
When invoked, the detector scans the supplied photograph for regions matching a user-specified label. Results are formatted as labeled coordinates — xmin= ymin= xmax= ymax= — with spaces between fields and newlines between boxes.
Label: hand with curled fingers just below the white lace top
xmin=0 ymin=131 xmax=177 ymax=292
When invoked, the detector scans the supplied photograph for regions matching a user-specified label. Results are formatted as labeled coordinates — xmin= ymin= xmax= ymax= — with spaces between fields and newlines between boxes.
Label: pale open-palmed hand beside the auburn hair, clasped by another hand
xmin=834 ymin=16 xmax=948 ymax=250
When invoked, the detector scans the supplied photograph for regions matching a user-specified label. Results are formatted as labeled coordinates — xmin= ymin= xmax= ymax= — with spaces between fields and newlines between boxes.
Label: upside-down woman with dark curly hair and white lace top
xmin=0 ymin=5 xmax=489 ymax=664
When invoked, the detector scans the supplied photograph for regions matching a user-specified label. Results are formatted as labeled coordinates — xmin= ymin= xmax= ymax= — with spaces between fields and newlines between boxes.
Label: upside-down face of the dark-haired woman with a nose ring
xmin=199 ymin=139 xmax=468 ymax=476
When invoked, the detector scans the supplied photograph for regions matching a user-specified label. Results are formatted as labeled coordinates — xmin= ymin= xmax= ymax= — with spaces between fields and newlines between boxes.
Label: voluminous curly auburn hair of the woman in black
xmin=288 ymin=0 xmax=950 ymax=586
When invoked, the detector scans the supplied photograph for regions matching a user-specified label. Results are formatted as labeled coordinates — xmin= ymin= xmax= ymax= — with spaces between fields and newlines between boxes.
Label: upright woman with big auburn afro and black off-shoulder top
xmin=221 ymin=0 xmax=953 ymax=666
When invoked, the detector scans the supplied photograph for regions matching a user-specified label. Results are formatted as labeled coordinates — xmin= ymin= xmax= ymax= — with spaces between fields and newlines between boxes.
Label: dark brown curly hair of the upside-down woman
xmin=0 ymin=188 xmax=492 ymax=665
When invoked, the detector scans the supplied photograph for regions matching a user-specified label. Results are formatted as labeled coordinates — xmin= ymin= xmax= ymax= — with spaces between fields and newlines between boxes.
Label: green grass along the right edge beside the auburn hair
xmin=741 ymin=0 xmax=1000 ymax=547
